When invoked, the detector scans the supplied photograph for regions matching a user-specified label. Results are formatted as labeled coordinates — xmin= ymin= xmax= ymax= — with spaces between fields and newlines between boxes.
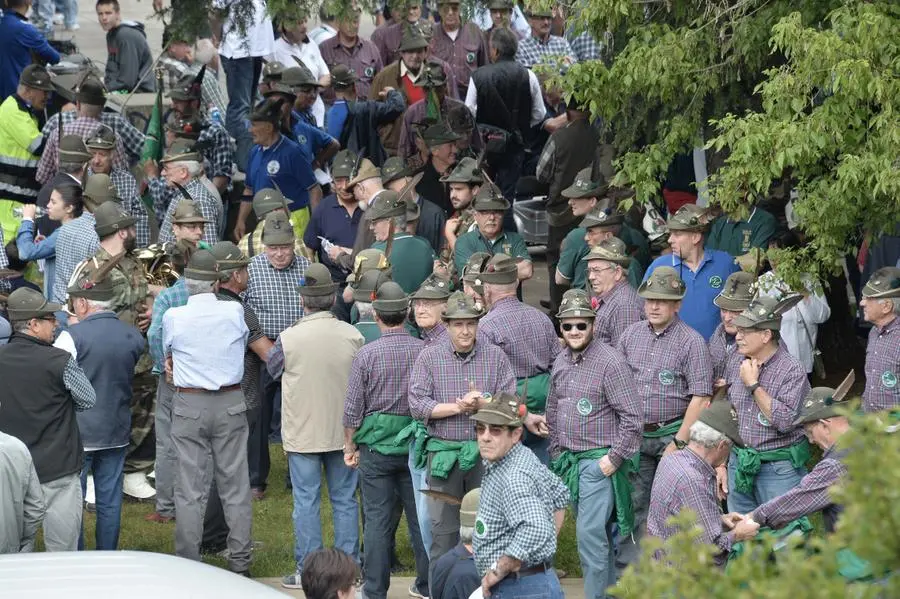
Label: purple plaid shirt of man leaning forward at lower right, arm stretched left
xmin=753 ymin=445 xmax=847 ymax=529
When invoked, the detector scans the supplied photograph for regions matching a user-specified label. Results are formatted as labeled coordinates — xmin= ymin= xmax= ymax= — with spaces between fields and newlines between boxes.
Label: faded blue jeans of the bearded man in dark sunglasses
xmin=580 ymin=460 xmax=616 ymax=599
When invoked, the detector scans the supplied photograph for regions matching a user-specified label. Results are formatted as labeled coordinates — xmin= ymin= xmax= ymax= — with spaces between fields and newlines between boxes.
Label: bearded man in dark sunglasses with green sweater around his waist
xmin=547 ymin=289 xmax=642 ymax=599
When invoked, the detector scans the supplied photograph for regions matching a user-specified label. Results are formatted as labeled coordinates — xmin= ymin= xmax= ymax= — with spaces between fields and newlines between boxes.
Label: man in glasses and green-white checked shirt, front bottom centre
xmin=470 ymin=393 xmax=569 ymax=599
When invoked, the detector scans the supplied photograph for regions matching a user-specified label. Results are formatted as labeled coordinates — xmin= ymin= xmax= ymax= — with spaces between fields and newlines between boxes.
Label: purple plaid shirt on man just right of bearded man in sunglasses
xmin=617 ymin=315 xmax=713 ymax=424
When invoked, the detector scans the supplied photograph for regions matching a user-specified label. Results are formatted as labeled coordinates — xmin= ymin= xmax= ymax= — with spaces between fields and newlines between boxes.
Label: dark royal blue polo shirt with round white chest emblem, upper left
xmin=243 ymin=135 xmax=317 ymax=212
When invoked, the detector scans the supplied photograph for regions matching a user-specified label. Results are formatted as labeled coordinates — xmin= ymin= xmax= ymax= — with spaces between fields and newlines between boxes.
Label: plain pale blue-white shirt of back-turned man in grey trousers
xmin=163 ymin=293 xmax=250 ymax=391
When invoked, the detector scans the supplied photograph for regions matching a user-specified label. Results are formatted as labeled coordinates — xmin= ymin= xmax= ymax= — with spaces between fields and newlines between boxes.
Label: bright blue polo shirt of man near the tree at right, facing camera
xmin=644 ymin=249 xmax=740 ymax=341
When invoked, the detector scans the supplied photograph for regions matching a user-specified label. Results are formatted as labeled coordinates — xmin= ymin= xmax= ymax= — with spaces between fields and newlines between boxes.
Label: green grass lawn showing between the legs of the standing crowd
xmin=77 ymin=445 xmax=580 ymax=577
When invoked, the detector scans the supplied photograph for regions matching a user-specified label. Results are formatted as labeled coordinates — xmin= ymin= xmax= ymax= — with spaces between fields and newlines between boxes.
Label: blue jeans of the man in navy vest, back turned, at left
xmin=78 ymin=447 xmax=128 ymax=551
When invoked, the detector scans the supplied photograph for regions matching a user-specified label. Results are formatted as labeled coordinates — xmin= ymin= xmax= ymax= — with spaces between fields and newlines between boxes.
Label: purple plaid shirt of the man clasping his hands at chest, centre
xmin=409 ymin=335 xmax=516 ymax=441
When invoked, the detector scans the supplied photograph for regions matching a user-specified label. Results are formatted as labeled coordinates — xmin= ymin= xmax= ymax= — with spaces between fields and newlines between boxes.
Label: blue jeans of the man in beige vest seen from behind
xmin=288 ymin=451 xmax=359 ymax=572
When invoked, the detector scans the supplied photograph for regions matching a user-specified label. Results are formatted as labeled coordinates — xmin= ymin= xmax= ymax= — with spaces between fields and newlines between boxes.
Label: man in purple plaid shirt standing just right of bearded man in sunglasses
xmin=616 ymin=266 xmax=713 ymax=568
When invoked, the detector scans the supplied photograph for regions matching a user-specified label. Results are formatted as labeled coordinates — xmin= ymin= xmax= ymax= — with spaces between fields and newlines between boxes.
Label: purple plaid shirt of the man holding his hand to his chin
xmin=725 ymin=344 xmax=810 ymax=451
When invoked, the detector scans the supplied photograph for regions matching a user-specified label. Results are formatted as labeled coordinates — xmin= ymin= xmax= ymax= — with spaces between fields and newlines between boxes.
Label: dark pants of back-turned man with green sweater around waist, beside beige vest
xmin=359 ymin=446 xmax=428 ymax=599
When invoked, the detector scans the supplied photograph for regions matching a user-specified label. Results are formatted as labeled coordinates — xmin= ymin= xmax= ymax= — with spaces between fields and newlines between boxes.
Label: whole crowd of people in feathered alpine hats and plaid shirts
xmin=0 ymin=0 xmax=900 ymax=599
